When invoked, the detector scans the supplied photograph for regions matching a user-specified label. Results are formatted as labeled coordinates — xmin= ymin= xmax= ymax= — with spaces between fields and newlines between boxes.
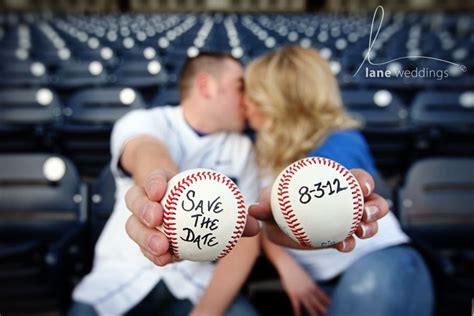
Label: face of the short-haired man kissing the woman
xmin=216 ymin=59 xmax=245 ymax=132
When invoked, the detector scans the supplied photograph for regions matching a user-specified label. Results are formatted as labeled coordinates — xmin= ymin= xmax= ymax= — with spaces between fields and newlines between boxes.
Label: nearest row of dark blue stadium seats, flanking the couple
xmin=0 ymin=154 xmax=474 ymax=315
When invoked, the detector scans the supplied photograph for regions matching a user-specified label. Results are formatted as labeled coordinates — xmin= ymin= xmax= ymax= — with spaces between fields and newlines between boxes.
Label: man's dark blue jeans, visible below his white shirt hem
xmin=67 ymin=282 xmax=258 ymax=316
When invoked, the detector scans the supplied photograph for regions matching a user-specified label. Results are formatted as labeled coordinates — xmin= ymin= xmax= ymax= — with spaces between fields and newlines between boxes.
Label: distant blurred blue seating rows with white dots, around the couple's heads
xmin=0 ymin=12 xmax=474 ymax=90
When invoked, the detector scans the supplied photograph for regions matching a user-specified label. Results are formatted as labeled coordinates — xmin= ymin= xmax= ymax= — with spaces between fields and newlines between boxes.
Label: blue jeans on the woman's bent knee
xmin=319 ymin=245 xmax=434 ymax=316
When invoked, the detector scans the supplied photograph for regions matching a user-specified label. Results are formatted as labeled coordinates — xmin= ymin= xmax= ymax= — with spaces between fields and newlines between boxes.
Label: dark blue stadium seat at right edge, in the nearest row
xmin=400 ymin=158 xmax=474 ymax=248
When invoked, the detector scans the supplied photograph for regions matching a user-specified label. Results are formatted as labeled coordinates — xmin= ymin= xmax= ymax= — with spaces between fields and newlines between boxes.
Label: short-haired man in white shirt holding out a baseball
xmin=70 ymin=53 xmax=259 ymax=315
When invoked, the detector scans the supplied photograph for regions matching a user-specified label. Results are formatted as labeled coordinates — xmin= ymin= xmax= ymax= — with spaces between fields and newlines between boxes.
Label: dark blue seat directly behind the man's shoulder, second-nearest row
xmin=56 ymin=88 xmax=146 ymax=177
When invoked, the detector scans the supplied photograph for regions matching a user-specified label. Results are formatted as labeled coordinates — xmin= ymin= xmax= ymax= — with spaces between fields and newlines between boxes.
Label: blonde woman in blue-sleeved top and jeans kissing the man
xmin=245 ymin=47 xmax=433 ymax=315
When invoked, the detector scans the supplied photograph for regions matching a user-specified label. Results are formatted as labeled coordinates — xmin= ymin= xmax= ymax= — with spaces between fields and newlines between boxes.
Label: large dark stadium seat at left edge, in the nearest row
xmin=0 ymin=154 xmax=87 ymax=315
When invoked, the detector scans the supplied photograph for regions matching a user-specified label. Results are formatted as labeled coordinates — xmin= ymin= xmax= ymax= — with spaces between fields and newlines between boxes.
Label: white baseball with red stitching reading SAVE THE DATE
xmin=161 ymin=169 xmax=247 ymax=261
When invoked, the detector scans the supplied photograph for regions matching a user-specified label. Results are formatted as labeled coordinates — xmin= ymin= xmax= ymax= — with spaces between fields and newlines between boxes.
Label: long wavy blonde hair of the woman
xmin=245 ymin=46 xmax=360 ymax=175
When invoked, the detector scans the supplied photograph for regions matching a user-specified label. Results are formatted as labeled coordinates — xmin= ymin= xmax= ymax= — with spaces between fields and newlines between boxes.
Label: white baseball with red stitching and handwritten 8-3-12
xmin=271 ymin=157 xmax=364 ymax=248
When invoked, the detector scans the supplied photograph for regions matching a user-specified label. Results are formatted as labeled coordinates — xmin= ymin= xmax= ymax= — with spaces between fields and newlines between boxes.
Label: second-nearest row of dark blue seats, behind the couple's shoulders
xmin=0 ymin=87 xmax=474 ymax=177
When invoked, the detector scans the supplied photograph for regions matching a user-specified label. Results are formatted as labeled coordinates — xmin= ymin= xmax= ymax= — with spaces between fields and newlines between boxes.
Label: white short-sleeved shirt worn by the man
xmin=73 ymin=106 xmax=259 ymax=315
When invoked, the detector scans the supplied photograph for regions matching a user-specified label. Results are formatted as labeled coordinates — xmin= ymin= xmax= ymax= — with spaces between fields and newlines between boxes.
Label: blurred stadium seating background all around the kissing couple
xmin=0 ymin=0 xmax=474 ymax=316
